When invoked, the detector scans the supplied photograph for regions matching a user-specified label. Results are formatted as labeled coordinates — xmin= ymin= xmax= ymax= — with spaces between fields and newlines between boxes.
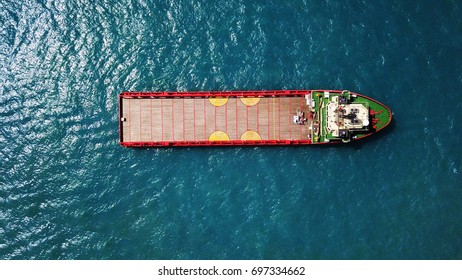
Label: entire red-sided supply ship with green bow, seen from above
xmin=119 ymin=90 xmax=392 ymax=147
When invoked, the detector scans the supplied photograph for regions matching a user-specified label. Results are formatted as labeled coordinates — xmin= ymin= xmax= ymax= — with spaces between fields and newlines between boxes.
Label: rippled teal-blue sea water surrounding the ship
xmin=0 ymin=0 xmax=462 ymax=259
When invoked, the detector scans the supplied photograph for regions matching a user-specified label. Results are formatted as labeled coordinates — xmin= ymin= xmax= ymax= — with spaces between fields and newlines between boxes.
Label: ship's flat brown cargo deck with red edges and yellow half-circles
xmin=119 ymin=91 xmax=311 ymax=147
